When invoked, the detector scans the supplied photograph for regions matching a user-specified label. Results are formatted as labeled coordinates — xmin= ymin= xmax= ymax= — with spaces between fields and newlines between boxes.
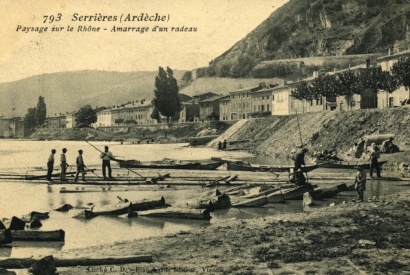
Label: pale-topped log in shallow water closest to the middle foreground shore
xmin=138 ymin=207 xmax=212 ymax=220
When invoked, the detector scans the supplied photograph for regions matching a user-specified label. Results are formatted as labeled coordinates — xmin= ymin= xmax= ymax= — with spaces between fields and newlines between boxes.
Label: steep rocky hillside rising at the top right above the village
xmin=210 ymin=0 xmax=410 ymax=76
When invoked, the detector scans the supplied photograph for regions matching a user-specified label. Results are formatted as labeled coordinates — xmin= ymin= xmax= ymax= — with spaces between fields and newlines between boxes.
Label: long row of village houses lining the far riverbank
xmin=0 ymin=50 xmax=410 ymax=137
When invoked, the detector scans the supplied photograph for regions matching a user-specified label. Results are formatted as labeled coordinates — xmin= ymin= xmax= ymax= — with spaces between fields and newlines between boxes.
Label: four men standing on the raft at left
xmin=47 ymin=146 xmax=115 ymax=182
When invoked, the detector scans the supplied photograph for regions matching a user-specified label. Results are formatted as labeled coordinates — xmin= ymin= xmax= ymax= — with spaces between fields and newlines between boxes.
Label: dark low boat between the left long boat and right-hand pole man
xmin=226 ymin=161 xmax=318 ymax=172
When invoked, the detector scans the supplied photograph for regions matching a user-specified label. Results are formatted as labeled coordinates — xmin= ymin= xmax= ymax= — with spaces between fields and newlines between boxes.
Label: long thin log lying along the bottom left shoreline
xmin=0 ymin=255 xmax=152 ymax=269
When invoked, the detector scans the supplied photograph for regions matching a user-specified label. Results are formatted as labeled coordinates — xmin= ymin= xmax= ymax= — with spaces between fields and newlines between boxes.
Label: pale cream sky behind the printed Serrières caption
xmin=0 ymin=0 xmax=287 ymax=83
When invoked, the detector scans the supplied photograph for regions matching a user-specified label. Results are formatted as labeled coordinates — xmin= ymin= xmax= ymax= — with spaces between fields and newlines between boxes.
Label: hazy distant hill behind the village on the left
xmin=0 ymin=71 xmax=184 ymax=116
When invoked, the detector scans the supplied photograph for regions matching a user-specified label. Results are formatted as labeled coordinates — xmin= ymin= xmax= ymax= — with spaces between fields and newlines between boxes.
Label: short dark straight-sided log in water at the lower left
xmin=11 ymin=229 xmax=65 ymax=242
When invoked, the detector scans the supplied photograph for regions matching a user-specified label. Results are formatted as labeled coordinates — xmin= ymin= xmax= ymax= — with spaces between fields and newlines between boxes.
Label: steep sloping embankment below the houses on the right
xmin=224 ymin=107 xmax=410 ymax=166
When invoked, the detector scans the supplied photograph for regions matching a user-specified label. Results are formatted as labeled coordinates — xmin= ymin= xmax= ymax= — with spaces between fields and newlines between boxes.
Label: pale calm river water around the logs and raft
xmin=0 ymin=140 xmax=401 ymax=257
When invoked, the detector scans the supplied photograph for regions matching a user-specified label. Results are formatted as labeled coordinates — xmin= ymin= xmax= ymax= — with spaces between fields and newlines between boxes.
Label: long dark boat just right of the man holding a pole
xmin=118 ymin=160 xmax=224 ymax=170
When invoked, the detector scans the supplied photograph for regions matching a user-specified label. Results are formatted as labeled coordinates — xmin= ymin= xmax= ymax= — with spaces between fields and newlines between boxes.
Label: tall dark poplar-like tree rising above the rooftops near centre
xmin=152 ymin=67 xmax=182 ymax=123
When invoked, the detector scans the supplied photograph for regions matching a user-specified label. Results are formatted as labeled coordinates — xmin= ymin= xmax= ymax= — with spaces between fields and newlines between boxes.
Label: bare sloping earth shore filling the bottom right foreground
xmin=50 ymin=191 xmax=410 ymax=274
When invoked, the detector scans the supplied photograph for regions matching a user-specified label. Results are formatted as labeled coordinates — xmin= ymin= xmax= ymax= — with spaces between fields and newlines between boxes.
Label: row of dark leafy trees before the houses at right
xmin=292 ymin=57 xmax=410 ymax=100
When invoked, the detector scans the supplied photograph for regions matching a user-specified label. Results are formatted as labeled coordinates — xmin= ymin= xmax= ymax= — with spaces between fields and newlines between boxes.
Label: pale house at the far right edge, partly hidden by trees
xmin=377 ymin=50 xmax=410 ymax=109
